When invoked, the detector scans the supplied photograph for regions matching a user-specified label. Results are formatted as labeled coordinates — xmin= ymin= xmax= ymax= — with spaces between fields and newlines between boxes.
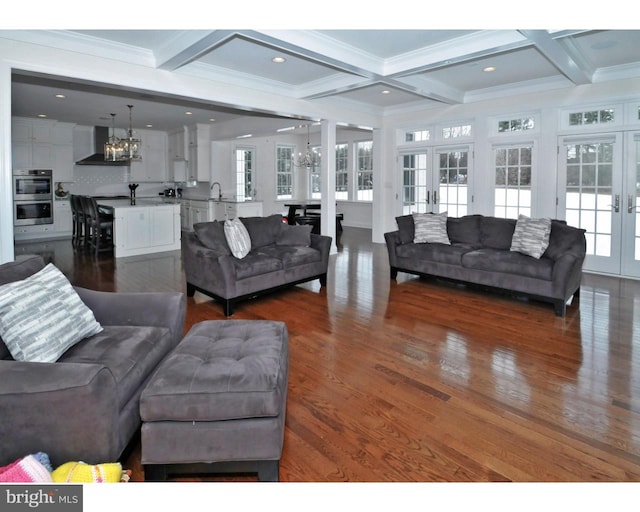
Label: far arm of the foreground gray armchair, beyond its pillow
xmin=75 ymin=287 xmax=187 ymax=346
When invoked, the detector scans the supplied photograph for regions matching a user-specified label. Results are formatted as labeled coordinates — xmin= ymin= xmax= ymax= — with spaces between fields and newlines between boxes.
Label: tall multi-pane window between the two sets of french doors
xmin=494 ymin=145 xmax=533 ymax=219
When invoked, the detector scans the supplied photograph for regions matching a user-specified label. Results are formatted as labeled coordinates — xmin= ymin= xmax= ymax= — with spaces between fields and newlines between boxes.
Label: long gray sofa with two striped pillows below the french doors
xmin=385 ymin=215 xmax=586 ymax=316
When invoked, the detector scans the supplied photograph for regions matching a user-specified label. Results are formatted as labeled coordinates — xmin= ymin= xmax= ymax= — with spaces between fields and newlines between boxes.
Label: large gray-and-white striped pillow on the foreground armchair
xmin=0 ymin=263 xmax=102 ymax=363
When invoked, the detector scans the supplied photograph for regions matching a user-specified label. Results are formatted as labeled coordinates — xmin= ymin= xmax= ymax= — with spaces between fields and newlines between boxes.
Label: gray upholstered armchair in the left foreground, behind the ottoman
xmin=0 ymin=256 xmax=186 ymax=467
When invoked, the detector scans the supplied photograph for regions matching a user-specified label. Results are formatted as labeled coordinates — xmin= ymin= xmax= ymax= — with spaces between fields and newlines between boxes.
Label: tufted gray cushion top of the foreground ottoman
xmin=140 ymin=320 xmax=289 ymax=422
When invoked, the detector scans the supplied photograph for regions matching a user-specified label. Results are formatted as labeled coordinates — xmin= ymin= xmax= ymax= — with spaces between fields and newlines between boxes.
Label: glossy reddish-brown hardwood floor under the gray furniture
xmin=12 ymin=227 xmax=640 ymax=482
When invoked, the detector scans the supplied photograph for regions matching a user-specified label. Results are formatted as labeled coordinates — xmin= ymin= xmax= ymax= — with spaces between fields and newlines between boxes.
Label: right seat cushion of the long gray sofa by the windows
xmin=462 ymin=248 xmax=553 ymax=281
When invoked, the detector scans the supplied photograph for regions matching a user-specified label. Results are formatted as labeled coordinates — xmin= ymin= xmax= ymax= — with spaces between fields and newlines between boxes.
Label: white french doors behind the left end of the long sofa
xmin=400 ymin=146 xmax=473 ymax=217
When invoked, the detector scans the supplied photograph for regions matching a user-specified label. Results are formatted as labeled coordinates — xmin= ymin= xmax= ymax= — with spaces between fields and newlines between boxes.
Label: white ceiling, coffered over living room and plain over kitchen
xmin=5 ymin=29 xmax=640 ymax=137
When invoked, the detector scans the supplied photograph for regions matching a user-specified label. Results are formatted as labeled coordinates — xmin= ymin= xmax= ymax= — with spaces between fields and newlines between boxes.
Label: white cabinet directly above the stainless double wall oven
xmin=11 ymin=117 xmax=56 ymax=169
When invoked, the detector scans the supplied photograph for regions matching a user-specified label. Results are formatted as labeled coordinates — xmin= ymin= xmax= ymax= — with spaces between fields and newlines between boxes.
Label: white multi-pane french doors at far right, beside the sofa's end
xmin=558 ymin=133 xmax=640 ymax=277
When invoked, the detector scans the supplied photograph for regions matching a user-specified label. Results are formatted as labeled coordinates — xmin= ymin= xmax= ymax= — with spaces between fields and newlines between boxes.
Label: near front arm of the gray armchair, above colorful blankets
xmin=0 ymin=361 xmax=121 ymax=467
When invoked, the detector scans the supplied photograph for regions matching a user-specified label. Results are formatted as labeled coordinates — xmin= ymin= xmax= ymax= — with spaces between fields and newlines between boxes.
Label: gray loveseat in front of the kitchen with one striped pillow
xmin=182 ymin=214 xmax=331 ymax=316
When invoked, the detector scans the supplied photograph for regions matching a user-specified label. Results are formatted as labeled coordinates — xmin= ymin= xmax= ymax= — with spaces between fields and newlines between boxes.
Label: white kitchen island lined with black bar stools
xmin=98 ymin=198 xmax=180 ymax=258
